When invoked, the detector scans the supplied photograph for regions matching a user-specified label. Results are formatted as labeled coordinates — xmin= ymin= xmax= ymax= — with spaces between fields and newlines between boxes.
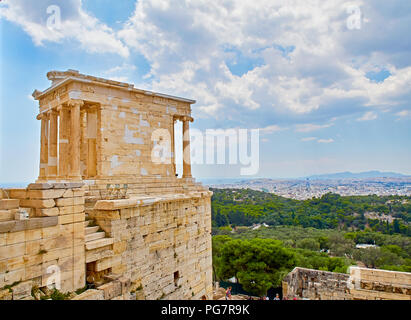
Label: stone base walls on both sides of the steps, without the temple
xmin=0 ymin=183 xmax=212 ymax=300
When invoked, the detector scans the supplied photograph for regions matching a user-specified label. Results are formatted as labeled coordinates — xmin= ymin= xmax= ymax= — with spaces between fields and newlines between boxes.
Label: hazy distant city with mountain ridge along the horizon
xmin=202 ymin=171 xmax=411 ymax=200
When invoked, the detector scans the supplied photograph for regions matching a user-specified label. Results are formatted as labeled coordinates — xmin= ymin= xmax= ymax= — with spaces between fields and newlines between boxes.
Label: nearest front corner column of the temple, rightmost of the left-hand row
xmin=69 ymin=100 xmax=83 ymax=180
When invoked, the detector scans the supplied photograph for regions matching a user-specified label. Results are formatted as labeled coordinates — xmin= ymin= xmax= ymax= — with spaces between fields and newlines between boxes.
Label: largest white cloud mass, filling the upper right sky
xmin=114 ymin=0 xmax=411 ymax=132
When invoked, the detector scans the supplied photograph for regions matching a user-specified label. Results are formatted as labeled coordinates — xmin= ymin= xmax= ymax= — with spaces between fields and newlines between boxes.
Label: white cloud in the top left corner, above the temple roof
xmin=0 ymin=0 xmax=129 ymax=57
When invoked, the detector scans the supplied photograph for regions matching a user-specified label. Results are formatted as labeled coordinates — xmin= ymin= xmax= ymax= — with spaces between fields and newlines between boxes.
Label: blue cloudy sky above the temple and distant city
xmin=0 ymin=0 xmax=411 ymax=182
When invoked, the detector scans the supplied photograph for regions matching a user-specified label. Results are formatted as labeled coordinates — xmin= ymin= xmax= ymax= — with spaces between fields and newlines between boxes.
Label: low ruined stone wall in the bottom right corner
xmin=283 ymin=267 xmax=411 ymax=300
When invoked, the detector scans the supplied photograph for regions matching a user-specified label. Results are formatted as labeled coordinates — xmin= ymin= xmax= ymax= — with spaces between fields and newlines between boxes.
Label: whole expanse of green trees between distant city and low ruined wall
xmin=212 ymin=189 xmax=411 ymax=295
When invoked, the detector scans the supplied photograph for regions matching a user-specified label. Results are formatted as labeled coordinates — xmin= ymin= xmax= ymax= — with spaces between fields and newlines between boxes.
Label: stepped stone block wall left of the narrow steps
xmin=0 ymin=183 xmax=85 ymax=299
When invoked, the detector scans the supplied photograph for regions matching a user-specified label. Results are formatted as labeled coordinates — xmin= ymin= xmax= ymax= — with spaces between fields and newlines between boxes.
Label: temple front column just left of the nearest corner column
xmin=57 ymin=106 xmax=70 ymax=179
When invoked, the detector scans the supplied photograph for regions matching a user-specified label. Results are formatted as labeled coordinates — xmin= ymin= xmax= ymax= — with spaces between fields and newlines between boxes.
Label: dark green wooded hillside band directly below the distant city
xmin=212 ymin=189 xmax=411 ymax=236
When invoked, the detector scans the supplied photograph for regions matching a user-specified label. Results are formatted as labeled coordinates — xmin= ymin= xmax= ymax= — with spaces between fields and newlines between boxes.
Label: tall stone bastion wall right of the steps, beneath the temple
xmin=90 ymin=192 xmax=212 ymax=299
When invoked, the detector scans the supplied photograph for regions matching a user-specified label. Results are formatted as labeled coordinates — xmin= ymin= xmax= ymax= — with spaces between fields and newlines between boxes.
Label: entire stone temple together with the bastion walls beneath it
xmin=0 ymin=70 xmax=212 ymax=300
